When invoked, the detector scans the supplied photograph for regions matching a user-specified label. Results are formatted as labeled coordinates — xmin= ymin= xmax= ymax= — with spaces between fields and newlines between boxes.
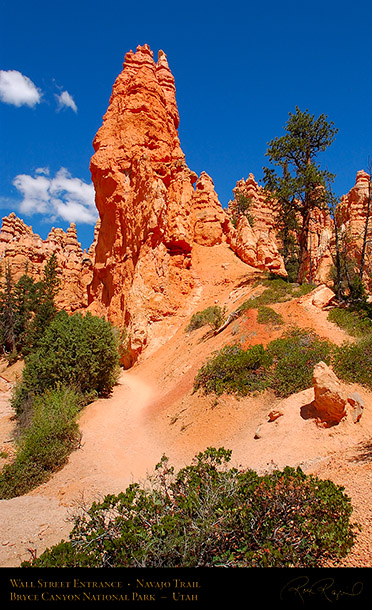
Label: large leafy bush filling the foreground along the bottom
xmin=22 ymin=448 xmax=355 ymax=568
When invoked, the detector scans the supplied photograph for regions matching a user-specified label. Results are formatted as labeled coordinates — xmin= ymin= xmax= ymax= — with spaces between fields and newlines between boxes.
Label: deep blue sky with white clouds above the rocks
xmin=0 ymin=0 xmax=372 ymax=247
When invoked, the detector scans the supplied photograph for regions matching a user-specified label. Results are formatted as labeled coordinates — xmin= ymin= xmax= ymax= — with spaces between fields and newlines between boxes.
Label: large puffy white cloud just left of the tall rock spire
xmin=13 ymin=167 xmax=98 ymax=225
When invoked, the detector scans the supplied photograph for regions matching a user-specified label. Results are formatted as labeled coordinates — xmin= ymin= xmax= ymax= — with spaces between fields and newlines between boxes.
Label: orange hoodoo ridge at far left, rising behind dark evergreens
xmin=0 ymin=212 xmax=92 ymax=312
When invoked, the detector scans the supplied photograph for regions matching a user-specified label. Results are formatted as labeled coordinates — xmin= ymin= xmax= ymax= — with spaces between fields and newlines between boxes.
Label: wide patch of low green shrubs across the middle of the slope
xmin=194 ymin=329 xmax=331 ymax=396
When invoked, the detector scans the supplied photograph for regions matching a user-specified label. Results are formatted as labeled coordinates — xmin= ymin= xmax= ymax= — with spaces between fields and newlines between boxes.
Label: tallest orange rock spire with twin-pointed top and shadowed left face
xmin=89 ymin=45 xmax=235 ymax=357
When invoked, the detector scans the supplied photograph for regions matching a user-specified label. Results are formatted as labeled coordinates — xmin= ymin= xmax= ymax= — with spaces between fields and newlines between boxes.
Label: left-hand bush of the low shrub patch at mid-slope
xmin=194 ymin=345 xmax=269 ymax=396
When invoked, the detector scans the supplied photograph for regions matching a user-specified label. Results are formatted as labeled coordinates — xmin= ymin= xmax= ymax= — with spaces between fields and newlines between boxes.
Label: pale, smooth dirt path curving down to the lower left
xmin=0 ymin=372 xmax=162 ymax=567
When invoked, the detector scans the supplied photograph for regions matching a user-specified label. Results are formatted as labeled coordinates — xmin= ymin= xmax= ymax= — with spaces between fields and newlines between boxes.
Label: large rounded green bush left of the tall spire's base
xmin=13 ymin=311 xmax=119 ymax=415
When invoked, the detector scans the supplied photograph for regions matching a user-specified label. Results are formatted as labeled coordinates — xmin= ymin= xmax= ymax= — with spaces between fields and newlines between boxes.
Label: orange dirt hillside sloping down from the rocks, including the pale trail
xmin=0 ymin=245 xmax=372 ymax=567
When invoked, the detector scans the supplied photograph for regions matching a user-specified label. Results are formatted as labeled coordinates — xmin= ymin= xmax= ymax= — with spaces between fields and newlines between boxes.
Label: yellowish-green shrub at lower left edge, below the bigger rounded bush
xmin=0 ymin=386 xmax=85 ymax=498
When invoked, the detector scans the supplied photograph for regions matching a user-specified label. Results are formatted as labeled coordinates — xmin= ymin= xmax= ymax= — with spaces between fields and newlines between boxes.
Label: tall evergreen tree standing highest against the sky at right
xmin=264 ymin=107 xmax=338 ymax=283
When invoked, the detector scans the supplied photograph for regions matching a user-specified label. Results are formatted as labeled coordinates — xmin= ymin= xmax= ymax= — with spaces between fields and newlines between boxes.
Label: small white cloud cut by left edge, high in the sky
xmin=0 ymin=70 xmax=42 ymax=108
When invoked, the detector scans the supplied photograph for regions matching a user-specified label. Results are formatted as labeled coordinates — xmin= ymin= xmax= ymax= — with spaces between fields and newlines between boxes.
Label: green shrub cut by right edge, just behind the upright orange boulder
xmin=333 ymin=334 xmax=372 ymax=389
